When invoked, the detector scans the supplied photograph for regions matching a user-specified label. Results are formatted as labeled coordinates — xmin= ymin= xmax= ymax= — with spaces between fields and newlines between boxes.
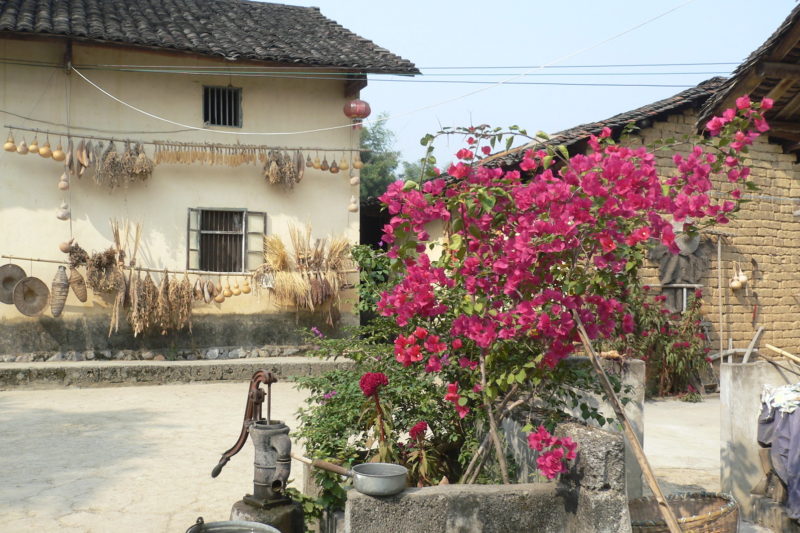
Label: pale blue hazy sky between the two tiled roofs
xmin=278 ymin=0 xmax=795 ymax=164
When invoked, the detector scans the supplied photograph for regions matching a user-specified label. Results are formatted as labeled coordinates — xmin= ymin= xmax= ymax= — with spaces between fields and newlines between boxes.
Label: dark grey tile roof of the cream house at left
xmin=0 ymin=0 xmax=419 ymax=74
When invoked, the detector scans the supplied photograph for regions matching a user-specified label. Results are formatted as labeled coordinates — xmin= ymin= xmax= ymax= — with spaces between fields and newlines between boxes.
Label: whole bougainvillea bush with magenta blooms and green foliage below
xmin=298 ymin=97 xmax=771 ymax=516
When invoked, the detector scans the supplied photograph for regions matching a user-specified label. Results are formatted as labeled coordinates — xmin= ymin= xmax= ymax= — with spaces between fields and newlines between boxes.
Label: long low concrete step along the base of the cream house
xmin=0 ymin=356 xmax=350 ymax=390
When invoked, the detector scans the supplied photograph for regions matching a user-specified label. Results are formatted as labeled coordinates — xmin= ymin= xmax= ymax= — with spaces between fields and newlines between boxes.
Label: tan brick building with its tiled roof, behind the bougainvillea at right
xmin=494 ymin=6 xmax=800 ymax=353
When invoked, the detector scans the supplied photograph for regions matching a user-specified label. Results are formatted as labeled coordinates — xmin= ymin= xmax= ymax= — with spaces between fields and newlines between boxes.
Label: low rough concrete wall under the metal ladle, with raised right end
xmin=345 ymin=423 xmax=631 ymax=533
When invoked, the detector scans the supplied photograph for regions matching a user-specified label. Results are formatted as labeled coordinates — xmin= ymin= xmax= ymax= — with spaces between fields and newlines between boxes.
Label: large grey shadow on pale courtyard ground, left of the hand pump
xmin=0 ymin=400 xmax=163 ymax=515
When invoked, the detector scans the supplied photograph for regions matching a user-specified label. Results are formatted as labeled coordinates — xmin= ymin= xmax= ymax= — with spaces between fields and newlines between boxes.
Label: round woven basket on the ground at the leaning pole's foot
xmin=628 ymin=492 xmax=739 ymax=533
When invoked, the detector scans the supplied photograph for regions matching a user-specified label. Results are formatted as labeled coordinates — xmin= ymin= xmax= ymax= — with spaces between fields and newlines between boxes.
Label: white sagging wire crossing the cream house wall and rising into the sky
xmin=71 ymin=0 xmax=696 ymax=136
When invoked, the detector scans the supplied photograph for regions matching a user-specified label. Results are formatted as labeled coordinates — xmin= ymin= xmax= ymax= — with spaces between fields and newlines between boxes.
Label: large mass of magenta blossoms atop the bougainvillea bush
xmin=378 ymin=98 xmax=772 ymax=417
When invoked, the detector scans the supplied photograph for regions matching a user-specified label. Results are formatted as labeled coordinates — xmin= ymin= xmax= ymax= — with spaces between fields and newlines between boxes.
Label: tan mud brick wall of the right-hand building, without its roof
xmin=627 ymin=110 xmax=800 ymax=354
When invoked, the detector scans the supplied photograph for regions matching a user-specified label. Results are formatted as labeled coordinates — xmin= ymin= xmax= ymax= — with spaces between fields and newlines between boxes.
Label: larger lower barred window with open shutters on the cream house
xmin=186 ymin=208 xmax=267 ymax=272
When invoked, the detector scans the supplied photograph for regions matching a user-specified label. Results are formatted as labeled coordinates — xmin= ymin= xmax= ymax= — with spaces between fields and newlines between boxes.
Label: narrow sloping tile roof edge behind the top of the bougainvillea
xmin=485 ymin=77 xmax=726 ymax=166
